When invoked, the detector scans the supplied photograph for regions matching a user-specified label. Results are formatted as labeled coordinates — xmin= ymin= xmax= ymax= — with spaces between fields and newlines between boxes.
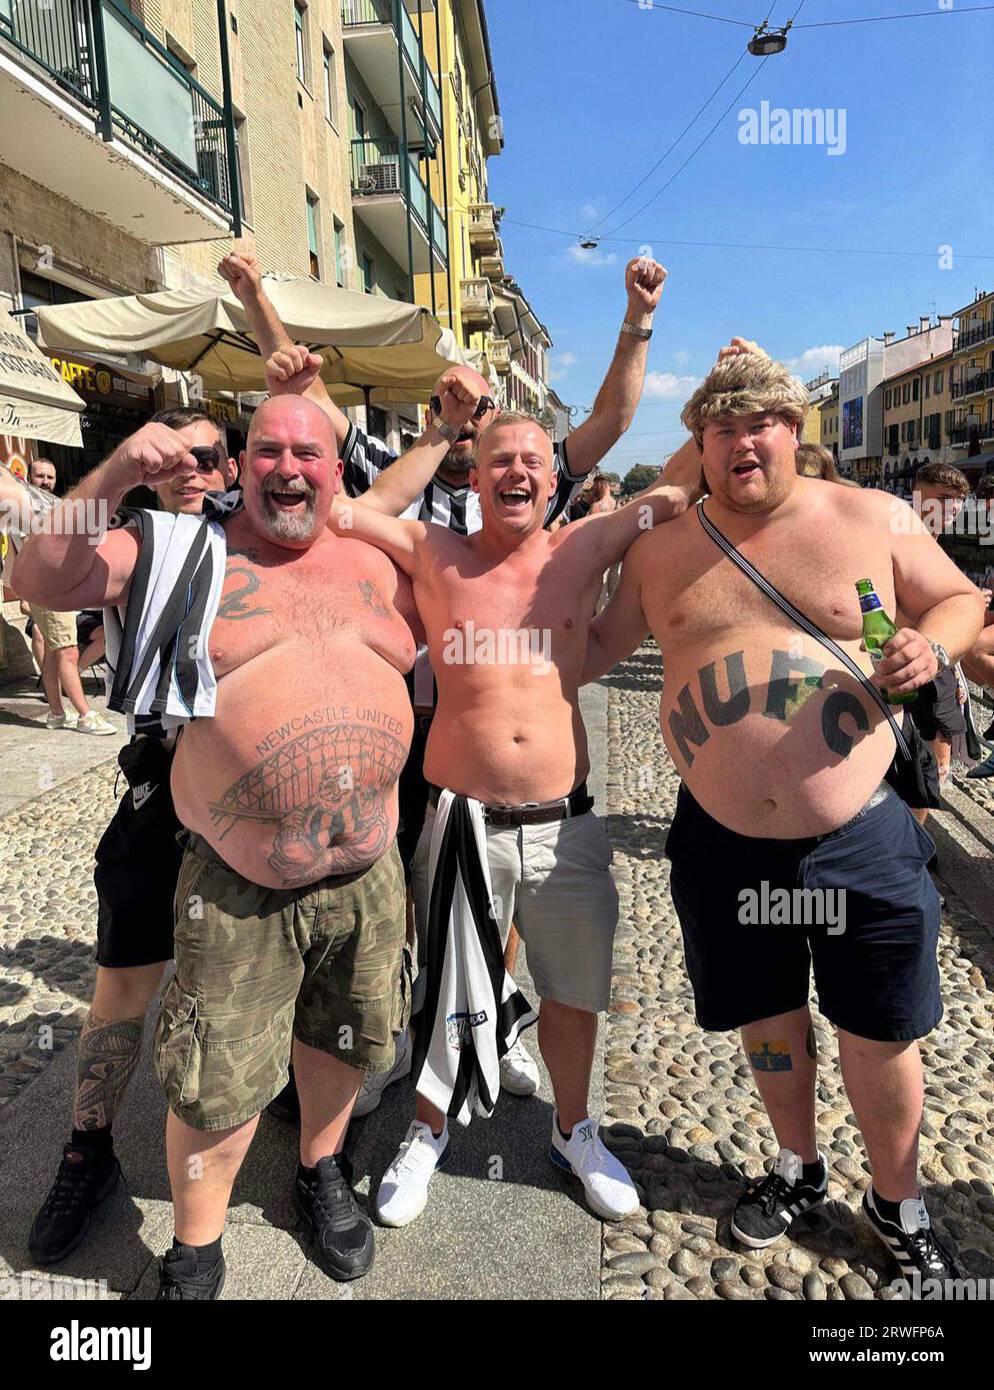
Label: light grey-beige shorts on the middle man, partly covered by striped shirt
xmin=412 ymin=803 xmax=617 ymax=1013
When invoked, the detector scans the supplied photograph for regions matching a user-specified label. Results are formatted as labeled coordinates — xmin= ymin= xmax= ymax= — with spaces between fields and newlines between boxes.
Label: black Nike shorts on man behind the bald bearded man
xmin=93 ymin=738 xmax=182 ymax=969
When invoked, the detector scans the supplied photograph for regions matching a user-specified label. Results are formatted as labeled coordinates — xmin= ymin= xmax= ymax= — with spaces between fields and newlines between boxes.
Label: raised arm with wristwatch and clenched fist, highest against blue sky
xmin=566 ymin=257 xmax=666 ymax=477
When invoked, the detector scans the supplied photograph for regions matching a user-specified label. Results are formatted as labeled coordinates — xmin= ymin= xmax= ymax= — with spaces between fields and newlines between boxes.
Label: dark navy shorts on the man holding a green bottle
xmin=666 ymin=785 xmax=943 ymax=1043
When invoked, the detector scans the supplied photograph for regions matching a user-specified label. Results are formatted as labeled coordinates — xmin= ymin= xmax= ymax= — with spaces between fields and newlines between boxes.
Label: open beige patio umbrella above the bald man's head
xmin=38 ymin=275 xmax=469 ymax=406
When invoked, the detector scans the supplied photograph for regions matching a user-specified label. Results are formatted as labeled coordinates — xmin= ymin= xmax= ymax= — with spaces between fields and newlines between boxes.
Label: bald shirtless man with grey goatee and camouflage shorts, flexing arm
xmin=15 ymin=398 xmax=414 ymax=1300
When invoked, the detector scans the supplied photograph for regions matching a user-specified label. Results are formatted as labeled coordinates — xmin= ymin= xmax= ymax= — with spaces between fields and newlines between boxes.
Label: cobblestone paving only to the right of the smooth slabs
xmin=602 ymin=645 xmax=994 ymax=1301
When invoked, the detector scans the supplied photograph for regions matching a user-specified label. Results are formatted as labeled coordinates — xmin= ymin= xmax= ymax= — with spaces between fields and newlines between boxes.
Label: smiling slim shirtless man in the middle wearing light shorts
xmin=322 ymin=411 xmax=699 ymax=1226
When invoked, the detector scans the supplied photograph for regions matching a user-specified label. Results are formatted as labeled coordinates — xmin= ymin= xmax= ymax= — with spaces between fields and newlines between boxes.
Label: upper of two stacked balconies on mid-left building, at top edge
xmin=341 ymin=0 xmax=442 ymax=140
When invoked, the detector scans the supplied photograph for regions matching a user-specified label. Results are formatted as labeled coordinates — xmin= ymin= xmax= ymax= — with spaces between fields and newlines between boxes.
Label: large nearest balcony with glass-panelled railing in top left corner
xmin=0 ymin=0 xmax=238 ymax=246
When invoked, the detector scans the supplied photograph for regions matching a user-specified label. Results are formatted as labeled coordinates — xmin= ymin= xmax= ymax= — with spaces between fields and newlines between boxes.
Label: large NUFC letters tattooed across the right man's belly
xmin=667 ymin=649 xmax=870 ymax=767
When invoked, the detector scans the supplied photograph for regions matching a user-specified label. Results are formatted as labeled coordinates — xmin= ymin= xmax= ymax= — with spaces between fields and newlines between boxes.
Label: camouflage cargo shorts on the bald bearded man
xmin=156 ymin=833 xmax=410 ymax=1130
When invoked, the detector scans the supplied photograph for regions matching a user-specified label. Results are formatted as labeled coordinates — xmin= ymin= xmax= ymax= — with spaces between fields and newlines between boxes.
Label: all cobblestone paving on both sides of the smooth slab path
xmin=0 ymin=646 xmax=994 ymax=1300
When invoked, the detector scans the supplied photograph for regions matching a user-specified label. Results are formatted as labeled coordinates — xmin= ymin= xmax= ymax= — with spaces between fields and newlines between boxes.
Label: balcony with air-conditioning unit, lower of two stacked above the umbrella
xmin=352 ymin=139 xmax=449 ymax=275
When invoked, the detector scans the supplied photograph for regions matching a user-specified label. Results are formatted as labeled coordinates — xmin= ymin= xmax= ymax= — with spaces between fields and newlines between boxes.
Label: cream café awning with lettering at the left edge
xmin=0 ymin=309 xmax=86 ymax=449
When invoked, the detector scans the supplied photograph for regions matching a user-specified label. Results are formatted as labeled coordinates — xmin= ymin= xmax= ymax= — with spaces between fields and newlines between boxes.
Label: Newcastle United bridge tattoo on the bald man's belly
xmin=210 ymin=720 xmax=407 ymax=887
